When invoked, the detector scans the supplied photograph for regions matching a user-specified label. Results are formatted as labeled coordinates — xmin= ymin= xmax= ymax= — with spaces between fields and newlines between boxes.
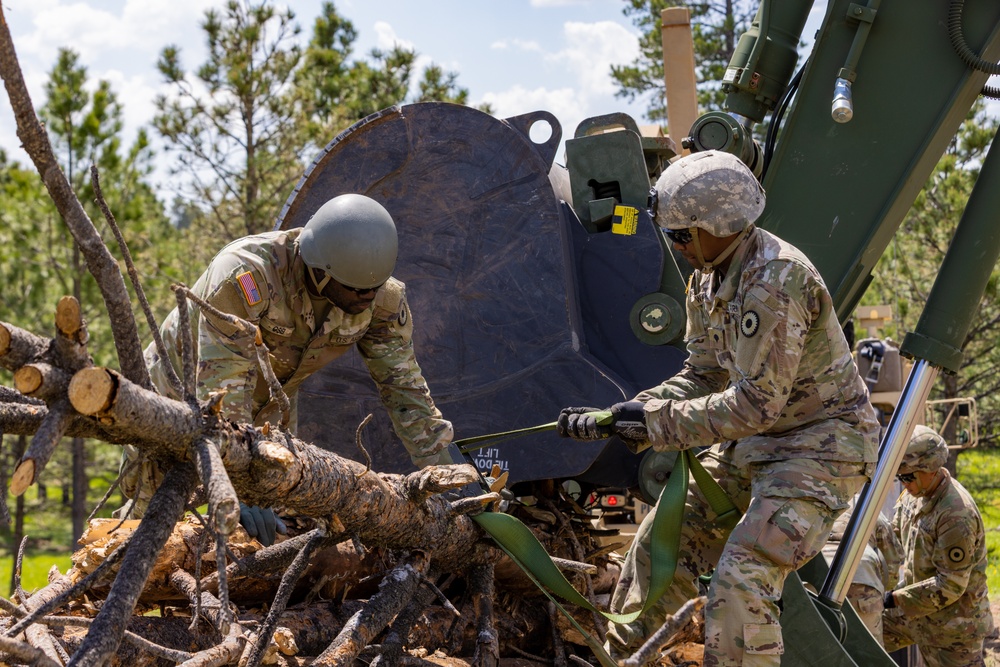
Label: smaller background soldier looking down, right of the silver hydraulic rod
xmin=884 ymin=426 xmax=993 ymax=667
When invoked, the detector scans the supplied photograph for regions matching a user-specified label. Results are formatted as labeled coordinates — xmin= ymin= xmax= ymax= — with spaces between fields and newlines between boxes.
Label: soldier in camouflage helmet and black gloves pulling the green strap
xmin=558 ymin=151 xmax=879 ymax=667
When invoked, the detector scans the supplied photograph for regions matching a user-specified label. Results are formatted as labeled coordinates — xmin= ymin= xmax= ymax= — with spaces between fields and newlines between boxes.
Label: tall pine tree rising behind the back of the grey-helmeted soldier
xmin=153 ymin=0 xmax=304 ymax=240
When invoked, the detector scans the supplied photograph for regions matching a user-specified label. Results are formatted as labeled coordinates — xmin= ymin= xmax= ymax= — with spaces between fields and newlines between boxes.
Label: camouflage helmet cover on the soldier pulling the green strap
xmin=655 ymin=150 xmax=765 ymax=237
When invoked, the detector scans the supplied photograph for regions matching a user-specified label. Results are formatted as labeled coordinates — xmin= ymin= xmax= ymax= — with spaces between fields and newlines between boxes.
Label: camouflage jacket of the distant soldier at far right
xmin=893 ymin=468 xmax=991 ymax=637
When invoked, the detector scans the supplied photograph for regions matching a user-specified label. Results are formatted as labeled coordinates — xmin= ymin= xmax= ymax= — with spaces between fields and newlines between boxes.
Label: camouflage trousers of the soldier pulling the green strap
xmin=607 ymin=445 xmax=867 ymax=667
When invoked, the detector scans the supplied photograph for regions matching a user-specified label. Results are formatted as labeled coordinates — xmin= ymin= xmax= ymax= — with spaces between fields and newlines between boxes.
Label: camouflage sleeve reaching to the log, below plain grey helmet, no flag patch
xmin=358 ymin=281 xmax=453 ymax=468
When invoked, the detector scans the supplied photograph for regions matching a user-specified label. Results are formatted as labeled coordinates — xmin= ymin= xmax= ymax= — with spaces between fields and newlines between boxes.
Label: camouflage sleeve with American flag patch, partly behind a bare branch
xmin=192 ymin=255 xmax=268 ymax=422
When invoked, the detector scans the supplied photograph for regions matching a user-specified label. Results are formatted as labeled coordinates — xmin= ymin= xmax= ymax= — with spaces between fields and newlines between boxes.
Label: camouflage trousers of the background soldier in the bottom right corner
xmin=882 ymin=609 xmax=986 ymax=667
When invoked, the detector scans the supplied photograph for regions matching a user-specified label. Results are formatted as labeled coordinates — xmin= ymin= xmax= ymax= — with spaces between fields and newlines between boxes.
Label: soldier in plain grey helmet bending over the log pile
xmin=122 ymin=194 xmax=453 ymax=534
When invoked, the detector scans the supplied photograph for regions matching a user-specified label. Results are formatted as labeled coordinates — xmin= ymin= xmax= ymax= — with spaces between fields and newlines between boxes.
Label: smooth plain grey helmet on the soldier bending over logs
xmin=299 ymin=194 xmax=399 ymax=289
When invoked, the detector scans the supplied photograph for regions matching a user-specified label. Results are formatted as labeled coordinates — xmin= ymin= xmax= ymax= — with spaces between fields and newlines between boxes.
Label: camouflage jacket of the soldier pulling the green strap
xmin=637 ymin=228 xmax=879 ymax=465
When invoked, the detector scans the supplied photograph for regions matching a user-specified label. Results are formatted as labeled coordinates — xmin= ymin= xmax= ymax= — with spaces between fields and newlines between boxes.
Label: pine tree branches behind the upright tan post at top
xmin=611 ymin=0 xmax=758 ymax=130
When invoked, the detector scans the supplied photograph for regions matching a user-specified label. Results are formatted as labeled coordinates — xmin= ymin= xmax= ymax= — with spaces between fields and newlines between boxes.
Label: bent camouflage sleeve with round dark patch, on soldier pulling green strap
xmin=646 ymin=261 xmax=822 ymax=450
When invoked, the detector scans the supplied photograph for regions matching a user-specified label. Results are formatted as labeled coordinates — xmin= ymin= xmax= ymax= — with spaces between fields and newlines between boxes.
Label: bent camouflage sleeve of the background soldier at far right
xmin=894 ymin=517 xmax=978 ymax=617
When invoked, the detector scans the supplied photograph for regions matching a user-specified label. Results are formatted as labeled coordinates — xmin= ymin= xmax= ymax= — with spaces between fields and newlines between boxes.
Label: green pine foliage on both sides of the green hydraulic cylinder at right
xmin=861 ymin=103 xmax=1000 ymax=447
